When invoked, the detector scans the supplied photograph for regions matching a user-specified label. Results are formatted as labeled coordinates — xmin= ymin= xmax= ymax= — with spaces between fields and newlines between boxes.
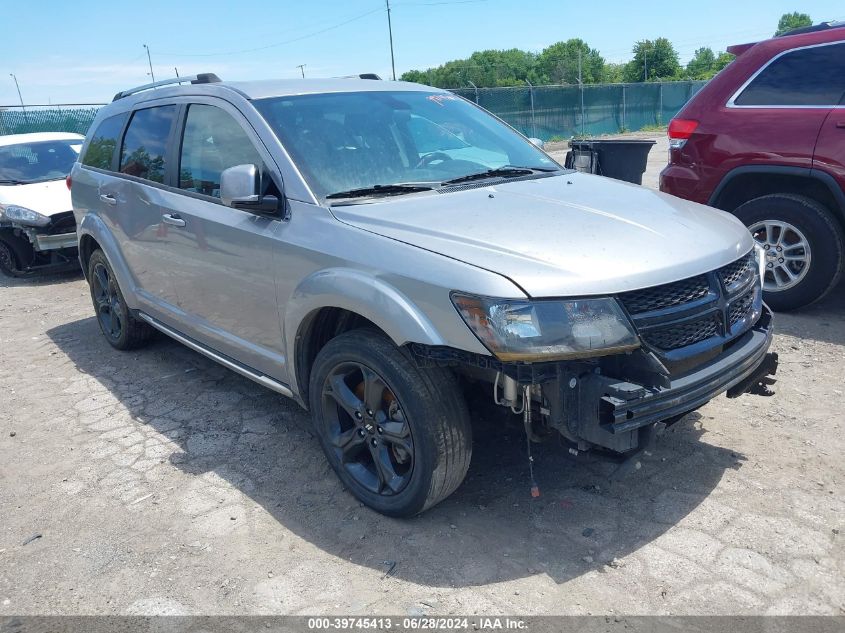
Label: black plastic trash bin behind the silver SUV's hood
xmin=565 ymin=139 xmax=657 ymax=185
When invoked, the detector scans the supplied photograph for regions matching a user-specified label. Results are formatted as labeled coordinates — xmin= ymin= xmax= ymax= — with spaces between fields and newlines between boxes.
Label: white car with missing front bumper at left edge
xmin=0 ymin=132 xmax=85 ymax=276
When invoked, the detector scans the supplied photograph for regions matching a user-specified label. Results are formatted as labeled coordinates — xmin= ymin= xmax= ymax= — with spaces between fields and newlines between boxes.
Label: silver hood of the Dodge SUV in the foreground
xmin=332 ymin=173 xmax=753 ymax=297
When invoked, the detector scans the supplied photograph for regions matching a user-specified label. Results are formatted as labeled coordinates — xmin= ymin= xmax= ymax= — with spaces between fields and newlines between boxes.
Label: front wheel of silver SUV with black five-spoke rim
xmin=309 ymin=330 xmax=472 ymax=517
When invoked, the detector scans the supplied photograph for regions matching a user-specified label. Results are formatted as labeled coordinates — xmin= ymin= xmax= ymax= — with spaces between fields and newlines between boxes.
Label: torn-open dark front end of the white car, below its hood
xmin=0 ymin=207 xmax=79 ymax=277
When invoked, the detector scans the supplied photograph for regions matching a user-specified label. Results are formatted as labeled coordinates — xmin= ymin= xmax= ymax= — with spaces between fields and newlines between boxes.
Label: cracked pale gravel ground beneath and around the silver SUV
xmin=0 ymin=147 xmax=845 ymax=615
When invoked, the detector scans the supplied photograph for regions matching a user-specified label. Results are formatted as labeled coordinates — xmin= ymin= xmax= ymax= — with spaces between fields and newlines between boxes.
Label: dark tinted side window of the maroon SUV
xmin=735 ymin=44 xmax=845 ymax=106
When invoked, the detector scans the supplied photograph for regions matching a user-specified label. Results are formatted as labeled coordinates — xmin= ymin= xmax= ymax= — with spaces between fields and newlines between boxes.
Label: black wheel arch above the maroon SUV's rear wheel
xmin=708 ymin=165 xmax=845 ymax=229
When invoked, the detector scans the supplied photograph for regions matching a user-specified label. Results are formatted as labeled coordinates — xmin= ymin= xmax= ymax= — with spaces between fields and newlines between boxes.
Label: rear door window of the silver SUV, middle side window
xmin=120 ymin=105 xmax=176 ymax=182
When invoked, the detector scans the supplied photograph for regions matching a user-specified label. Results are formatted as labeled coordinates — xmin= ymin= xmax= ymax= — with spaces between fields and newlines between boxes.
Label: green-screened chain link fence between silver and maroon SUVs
xmin=452 ymin=81 xmax=707 ymax=141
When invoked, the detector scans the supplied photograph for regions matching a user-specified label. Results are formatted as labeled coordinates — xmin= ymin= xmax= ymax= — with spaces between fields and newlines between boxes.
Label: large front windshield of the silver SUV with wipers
xmin=255 ymin=91 xmax=559 ymax=197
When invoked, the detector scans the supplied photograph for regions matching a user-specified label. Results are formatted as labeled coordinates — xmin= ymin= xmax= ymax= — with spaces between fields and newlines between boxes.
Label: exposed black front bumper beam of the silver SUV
xmin=543 ymin=306 xmax=777 ymax=453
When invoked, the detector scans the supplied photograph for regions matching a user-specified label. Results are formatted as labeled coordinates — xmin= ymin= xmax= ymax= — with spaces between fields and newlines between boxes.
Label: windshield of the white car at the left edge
xmin=0 ymin=139 xmax=82 ymax=184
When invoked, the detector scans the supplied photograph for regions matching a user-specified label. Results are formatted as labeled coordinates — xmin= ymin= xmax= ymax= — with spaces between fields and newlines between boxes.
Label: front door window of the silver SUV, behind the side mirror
xmin=179 ymin=104 xmax=263 ymax=198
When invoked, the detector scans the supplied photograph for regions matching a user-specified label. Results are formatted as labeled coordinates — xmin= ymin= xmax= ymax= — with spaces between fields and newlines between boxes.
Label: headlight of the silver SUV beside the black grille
xmin=452 ymin=292 xmax=640 ymax=361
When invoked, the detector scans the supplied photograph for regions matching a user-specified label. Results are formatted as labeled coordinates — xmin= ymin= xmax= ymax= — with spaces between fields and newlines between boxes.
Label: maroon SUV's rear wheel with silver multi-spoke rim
xmin=734 ymin=193 xmax=845 ymax=311
